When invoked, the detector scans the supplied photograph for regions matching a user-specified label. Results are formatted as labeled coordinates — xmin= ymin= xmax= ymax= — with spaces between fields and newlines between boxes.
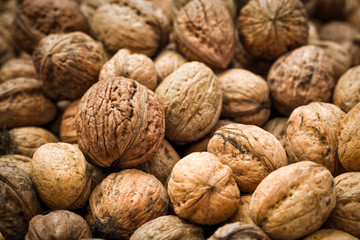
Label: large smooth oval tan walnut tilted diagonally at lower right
xmin=250 ymin=161 xmax=336 ymax=240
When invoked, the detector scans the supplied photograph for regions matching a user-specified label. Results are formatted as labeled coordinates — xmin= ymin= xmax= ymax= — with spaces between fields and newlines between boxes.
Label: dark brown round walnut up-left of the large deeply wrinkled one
xmin=33 ymin=32 xmax=106 ymax=100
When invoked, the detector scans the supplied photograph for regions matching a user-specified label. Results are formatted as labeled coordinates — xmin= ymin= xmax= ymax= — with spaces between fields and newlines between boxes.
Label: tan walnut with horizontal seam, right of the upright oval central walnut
xmin=218 ymin=69 xmax=270 ymax=126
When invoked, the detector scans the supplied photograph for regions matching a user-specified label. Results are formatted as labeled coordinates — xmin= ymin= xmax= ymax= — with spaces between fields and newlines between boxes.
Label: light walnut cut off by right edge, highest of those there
xmin=333 ymin=66 xmax=360 ymax=113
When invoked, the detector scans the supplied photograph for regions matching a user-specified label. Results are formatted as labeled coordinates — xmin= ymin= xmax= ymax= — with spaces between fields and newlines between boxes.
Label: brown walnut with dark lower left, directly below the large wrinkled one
xmin=89 ymin=169 xmax=169 ymax=239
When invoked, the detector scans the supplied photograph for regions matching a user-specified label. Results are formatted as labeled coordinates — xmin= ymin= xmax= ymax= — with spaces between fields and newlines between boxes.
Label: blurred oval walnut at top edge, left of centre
xmin=91 ymin=0 xmax=169 ymax=57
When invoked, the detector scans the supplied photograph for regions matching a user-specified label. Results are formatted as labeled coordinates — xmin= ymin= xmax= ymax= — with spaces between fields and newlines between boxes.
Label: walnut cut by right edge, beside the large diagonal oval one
xmin=326 ymin=172 xmax=360 ymax=238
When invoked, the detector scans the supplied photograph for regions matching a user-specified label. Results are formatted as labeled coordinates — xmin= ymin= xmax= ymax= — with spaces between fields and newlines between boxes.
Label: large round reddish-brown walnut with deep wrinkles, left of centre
xmin=75 ymin=77 xmax=165 ymax=168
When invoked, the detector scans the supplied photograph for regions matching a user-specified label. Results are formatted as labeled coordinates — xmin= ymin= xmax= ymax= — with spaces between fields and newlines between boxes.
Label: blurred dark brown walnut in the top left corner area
xmin=13 ymin=0 xmax=88 ymax=53
